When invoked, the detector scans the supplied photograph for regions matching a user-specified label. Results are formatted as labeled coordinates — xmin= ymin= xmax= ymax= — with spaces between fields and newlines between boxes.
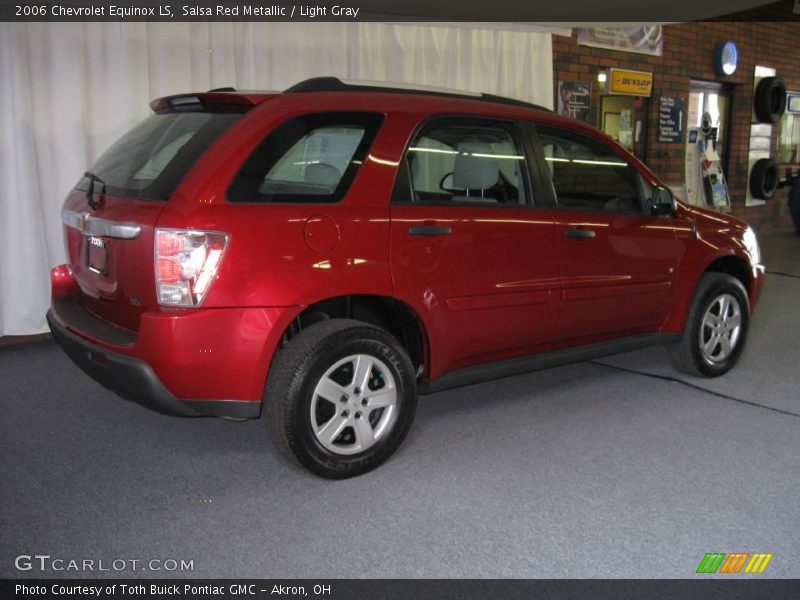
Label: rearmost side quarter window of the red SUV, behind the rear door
xmin=228 ymin=112 xmax=383 ymax=203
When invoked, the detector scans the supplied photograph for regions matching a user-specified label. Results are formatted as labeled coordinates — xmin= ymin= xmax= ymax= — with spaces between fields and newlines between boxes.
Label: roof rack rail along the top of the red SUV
xmin=283 ymin=77 xmax=552 ymax=112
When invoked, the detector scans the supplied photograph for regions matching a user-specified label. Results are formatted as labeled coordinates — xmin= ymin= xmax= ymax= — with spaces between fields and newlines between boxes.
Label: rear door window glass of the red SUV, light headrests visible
xmin=406 ymin=118 xmax=528 ymax=206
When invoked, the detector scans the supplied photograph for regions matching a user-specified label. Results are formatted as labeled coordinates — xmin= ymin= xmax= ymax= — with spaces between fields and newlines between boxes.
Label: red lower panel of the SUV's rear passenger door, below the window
xmin=391 ymin=205 xmax=559 ymax=378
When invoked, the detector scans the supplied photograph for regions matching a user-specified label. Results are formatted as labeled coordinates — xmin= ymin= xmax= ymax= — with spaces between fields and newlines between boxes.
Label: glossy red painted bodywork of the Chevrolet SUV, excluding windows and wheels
xmin=47 ymin=92 xmax=763 ymax=418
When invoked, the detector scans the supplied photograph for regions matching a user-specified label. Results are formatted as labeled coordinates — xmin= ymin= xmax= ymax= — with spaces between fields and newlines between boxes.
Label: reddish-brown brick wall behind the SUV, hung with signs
xmin=553 ymin=0 xmax=800 ymax=227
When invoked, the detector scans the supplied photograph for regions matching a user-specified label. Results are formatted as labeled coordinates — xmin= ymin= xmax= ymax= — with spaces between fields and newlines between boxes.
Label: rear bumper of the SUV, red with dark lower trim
xmin=47 ymin=296 xmax=290 ymax=418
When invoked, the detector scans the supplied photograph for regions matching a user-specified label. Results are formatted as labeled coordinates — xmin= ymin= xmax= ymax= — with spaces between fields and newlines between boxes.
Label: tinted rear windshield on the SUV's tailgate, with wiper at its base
xmin=76 ymin=112 xmax=241 ymax=200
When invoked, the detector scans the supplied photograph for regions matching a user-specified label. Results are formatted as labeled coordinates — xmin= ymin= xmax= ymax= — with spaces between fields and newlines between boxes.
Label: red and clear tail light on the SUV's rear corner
xmin=155 ymin=228 xmax=228 ymax=306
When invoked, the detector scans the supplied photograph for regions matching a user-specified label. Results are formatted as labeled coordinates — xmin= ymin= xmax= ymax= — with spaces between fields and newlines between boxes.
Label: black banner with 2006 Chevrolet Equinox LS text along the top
xmin=0 ymin=0 xmax=788 ymax=21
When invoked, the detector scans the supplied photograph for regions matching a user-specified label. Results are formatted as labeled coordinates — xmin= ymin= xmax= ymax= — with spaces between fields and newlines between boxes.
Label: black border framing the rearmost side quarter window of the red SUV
xmin=225 ymin=110 xmax=386 ymax=206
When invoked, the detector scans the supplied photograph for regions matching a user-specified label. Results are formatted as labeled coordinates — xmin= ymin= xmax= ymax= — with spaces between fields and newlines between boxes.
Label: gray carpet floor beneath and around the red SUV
xmin=0 ymin=233 xmax=800 ymax=578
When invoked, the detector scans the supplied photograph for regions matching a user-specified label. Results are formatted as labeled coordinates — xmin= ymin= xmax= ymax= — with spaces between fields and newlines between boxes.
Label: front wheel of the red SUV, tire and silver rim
xmin=669 ymin=273 xmax=750 ymax=377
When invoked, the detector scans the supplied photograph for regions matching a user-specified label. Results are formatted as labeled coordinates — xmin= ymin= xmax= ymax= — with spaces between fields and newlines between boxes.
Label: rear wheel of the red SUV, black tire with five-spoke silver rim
xmin=264 ymin=319 xmax=417 ymax=479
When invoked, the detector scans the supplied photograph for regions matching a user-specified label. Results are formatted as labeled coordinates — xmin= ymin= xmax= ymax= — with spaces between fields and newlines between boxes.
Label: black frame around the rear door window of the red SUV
xmin=391 ymin=113 xmax=541 ymax=210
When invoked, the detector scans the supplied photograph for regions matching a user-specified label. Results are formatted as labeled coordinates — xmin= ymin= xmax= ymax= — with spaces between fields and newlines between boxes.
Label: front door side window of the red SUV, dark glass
xmin=536 ymin=126 xmax=644 ymax=213
